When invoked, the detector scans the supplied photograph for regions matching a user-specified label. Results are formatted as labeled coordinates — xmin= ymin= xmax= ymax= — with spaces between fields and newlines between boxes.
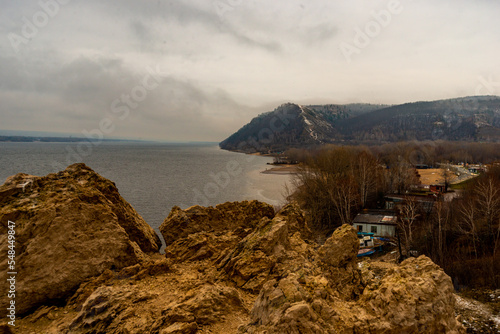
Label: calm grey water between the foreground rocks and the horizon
xmin=0 ymin=142 xmax=289 ymax=243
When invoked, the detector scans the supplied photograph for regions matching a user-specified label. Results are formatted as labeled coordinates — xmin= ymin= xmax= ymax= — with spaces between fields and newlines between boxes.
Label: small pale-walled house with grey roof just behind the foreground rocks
xmin=352 ymin=213 xmax=397 ymax=237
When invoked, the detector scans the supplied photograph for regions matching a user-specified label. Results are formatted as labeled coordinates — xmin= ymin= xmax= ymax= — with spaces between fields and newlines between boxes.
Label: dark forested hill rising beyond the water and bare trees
xmin=220 ymin=96 xmax=500 ymax=153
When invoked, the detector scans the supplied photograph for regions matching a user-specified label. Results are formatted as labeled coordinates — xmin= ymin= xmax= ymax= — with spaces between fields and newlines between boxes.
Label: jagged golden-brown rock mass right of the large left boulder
xmin=2 ymin=181 xmax=463 ymax=334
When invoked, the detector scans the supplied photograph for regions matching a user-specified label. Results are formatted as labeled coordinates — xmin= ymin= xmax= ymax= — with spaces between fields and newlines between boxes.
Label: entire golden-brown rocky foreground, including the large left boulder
xmin=0 ymin=164 xmax=465 ymax=334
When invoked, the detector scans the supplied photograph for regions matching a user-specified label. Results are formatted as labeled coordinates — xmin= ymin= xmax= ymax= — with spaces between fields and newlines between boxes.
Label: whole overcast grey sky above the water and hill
xmin=0 ymin=0 xmax=500 ymax=141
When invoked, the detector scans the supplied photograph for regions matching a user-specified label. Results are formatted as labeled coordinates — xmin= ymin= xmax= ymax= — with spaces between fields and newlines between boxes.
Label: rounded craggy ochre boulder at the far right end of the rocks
xmin=359 ymin=255 xmax=463 ymax=333
